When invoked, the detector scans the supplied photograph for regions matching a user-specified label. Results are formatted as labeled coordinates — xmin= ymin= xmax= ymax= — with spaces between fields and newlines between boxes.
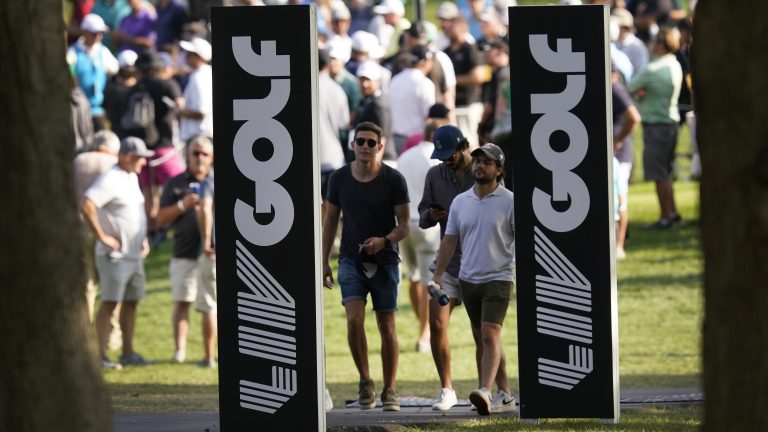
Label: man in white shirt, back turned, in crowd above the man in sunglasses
xmin=389 ymin=45 xmax=435 ymax=155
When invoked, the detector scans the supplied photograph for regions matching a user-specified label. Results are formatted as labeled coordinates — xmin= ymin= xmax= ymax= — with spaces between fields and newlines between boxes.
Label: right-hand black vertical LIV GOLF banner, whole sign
xmin=509 ymin=5 xmax=619 ymax=422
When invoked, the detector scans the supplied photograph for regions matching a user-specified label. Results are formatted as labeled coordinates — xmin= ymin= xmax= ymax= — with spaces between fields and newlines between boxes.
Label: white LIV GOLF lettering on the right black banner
xmin=528 ymin=34 xmax=593 ymax=390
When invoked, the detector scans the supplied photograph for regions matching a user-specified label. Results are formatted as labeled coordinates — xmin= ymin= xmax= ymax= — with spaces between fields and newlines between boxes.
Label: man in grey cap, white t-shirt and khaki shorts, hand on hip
xmin=80 ymin=137 xmax=155 ymax=369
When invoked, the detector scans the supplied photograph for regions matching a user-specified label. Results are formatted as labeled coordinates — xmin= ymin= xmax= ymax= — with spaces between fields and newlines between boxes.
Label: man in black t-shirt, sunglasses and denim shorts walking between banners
xmin=323 ymin=123 xmax=410 ymax=411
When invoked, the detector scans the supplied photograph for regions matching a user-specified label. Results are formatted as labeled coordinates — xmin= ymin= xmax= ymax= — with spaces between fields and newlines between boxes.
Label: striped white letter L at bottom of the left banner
xmin=240 ymin=366 xmax=296 ymax=414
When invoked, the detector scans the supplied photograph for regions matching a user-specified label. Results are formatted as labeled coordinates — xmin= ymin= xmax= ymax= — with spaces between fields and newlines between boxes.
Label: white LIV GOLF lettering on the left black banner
xmin=232 ymin=36 xmax=298 ymax=414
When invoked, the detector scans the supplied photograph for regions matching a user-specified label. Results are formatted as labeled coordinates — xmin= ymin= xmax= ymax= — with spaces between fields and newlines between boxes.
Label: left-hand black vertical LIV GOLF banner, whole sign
xmin=212 ymin=6 xmax=325 ymax=431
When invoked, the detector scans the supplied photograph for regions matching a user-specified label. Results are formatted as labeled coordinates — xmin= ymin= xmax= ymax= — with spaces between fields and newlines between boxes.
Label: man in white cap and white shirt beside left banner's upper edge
xmin=178 ymin=37 xmax=213 ymax=141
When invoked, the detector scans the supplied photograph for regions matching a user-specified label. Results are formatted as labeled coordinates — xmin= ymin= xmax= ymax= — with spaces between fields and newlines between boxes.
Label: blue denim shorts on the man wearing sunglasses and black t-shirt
xmin=336 ymin=258 xmax=400 ymax=312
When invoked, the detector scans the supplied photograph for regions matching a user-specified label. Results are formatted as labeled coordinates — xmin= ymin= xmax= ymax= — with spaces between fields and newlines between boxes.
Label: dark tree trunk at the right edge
xmin=692 ymin=0 xmax=768 ymax=432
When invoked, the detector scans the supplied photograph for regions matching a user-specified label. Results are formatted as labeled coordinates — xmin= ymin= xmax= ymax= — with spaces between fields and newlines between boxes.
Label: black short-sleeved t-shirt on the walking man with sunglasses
xmin=327 ymin=164 xmax=409 ymax=264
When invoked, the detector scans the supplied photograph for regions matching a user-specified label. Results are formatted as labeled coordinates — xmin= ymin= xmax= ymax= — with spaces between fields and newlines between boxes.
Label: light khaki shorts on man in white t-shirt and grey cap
xmin=96 ymin=255 xmax=147 ymax=303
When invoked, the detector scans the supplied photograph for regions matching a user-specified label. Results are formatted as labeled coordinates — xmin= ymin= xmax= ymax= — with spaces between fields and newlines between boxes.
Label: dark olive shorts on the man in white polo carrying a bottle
xmin=459 ymin=280 xmax=515 ymax=328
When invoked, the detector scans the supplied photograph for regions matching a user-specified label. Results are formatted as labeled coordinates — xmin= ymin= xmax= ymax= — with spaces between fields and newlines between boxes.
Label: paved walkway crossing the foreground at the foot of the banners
xmin=114 ymin=388 xmax=704 ymax=432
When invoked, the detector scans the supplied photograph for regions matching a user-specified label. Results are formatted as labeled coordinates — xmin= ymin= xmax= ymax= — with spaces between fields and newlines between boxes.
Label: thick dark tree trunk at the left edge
xmin=0 ymin=0 xmax=112 ymax=432
